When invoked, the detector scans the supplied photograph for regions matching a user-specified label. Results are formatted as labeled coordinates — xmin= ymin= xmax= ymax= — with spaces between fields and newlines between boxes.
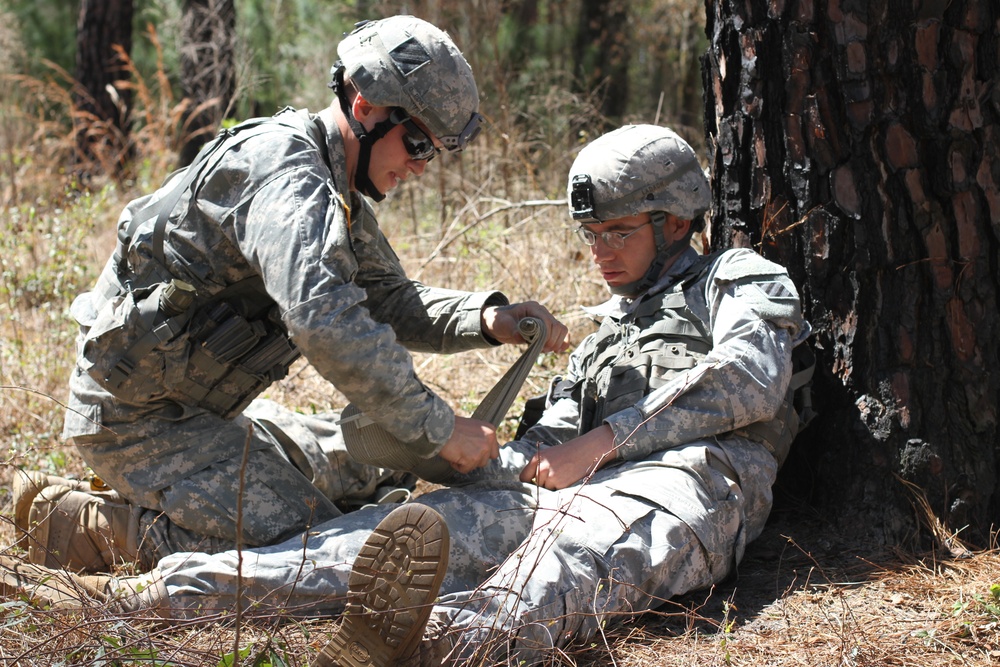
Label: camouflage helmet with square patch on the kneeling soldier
xmin=331 ymin=16 xmax=482 ymax=151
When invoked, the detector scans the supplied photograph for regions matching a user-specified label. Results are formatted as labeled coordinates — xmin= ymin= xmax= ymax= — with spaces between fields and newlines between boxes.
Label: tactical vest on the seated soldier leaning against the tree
xmin=518 ymin=255 xmax=815 ymax=465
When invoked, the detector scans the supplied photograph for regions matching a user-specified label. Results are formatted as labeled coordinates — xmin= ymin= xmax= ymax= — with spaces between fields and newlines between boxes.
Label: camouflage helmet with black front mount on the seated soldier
xmin=567 ymin=125 xmax=712 ymax=223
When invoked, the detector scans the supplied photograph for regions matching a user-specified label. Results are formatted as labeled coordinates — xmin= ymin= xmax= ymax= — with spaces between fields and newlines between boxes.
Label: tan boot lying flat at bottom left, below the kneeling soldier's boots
xmin=0 ymin=555 xmax=170 ymax=618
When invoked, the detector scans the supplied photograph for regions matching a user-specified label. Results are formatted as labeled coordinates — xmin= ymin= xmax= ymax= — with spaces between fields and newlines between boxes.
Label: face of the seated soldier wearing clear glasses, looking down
xmin=584 ymin=213 xmax=656 ymax=287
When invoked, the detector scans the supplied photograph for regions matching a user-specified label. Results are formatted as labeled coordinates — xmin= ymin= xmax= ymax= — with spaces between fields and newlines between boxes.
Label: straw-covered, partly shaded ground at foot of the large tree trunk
xmin=579 ymin=510 xmax=1000 ymax=667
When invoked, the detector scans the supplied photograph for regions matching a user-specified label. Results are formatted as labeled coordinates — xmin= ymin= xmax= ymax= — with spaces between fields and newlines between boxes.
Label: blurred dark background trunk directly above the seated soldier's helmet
xmin=573 ymin=0 xmax=631 ymax=124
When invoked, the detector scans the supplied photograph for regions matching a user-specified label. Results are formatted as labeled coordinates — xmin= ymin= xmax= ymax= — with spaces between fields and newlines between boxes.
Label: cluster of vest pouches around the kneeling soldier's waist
xmin=81 ymin=279 xmax=299 ymax=419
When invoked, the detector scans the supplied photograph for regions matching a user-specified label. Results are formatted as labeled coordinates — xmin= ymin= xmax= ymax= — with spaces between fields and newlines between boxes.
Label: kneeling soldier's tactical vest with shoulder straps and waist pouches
xmin=80 ymin=112 xmax=329 ymax=419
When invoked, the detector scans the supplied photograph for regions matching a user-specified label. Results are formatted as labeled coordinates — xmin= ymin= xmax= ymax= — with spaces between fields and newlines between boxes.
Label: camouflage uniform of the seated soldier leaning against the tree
xmin=145 ymin=243 xmax=810 ymax=664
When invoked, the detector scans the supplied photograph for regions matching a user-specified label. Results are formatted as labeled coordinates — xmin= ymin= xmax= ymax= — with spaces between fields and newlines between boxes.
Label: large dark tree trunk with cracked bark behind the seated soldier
xmin=704 ymin=0 xmax=1000 ymax=546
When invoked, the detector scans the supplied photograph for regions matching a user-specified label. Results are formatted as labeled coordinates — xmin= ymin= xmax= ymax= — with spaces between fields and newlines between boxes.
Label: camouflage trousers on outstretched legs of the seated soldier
xmin=159 ymin=443 xmax=774 ymax=664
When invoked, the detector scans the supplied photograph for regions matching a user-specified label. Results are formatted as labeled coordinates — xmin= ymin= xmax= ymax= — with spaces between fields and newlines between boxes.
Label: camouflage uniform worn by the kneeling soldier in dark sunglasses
xmin=64 ymin=109 xmax=507 ymax=563
